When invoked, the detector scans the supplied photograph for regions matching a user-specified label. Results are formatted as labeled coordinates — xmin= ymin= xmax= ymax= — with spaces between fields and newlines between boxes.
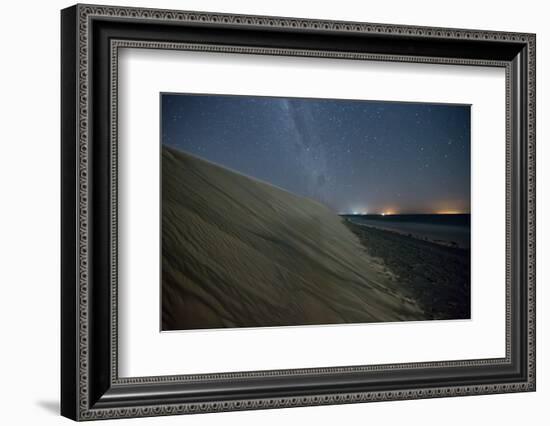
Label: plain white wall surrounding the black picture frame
xmin=0 ymin=0 xmax=550 ymax=426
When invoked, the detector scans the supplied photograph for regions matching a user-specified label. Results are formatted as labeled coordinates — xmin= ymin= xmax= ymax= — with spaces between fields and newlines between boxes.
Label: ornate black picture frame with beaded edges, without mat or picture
xmin=61 ymin=5 xmax=535 ymax=420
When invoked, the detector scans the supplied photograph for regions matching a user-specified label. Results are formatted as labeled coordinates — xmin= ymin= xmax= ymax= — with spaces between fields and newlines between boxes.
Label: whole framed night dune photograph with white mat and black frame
xmin=61 ymin=5 xmax=535 ymax=420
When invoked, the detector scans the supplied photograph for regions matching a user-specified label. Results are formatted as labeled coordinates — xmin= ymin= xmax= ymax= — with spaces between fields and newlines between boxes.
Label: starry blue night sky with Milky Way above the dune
xmin=161 ymin=94 xmax=470 ymax=214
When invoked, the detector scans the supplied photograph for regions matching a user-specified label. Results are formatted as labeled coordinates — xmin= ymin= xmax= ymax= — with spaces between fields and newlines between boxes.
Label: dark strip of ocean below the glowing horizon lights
xmin=342 ymin=214 xmax=471 ymax=249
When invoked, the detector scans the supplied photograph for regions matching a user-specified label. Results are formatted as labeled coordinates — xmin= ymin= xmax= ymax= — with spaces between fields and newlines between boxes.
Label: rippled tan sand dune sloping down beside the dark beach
xmin=162 ymin=147 xmax=424 ymax=330
